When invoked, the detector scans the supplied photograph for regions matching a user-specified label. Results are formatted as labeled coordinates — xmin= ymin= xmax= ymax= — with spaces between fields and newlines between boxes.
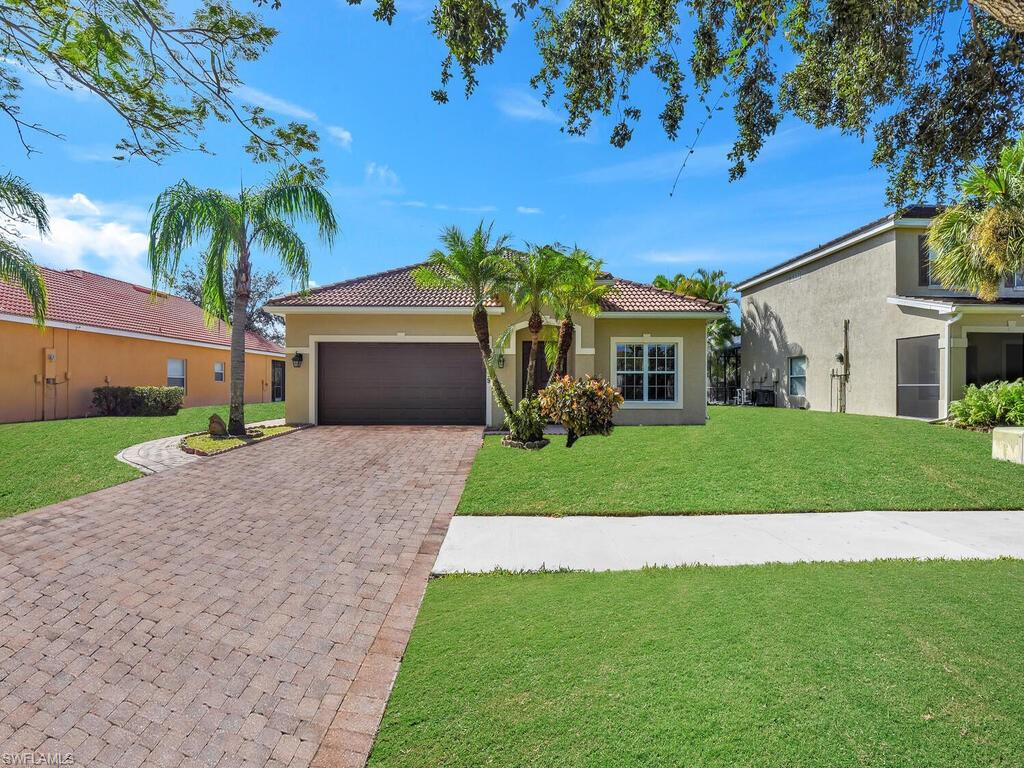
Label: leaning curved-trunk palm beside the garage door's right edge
xmin=413 ymin=221 xmax=513 ymax=417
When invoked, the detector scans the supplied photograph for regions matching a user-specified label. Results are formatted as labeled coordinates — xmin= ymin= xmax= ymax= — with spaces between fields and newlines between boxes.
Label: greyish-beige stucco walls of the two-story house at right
xmin=741 ymin=221 xmax=1024 ymax=417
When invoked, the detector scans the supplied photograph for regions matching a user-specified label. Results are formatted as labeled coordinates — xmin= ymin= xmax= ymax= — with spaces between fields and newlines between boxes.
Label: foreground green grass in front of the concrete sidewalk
xmin=370 ymin=560 xmax=1024 ymax=768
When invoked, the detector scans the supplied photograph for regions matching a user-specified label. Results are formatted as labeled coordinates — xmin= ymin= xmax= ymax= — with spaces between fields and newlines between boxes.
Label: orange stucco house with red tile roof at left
xmin=0 ymin=267 xmax=285 ymax=422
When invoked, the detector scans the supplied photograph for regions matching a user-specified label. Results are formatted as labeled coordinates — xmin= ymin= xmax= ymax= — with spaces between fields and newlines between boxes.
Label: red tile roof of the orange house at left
xmin=0 ymin=267 xmax=285 ymax=354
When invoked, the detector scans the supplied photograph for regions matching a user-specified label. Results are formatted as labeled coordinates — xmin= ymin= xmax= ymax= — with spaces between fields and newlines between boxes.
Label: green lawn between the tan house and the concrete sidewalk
xmin=459 ymin=408 xmax=1024 ymax=515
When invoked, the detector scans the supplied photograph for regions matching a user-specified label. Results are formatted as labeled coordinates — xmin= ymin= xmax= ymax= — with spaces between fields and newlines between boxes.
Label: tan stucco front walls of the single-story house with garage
xmin=276 ymin=308 xmax=707 ymax=428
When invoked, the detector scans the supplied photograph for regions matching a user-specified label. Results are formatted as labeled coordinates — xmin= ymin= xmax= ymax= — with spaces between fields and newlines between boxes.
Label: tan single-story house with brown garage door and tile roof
xmin=265 ymin=264 xmax=722 ymax=428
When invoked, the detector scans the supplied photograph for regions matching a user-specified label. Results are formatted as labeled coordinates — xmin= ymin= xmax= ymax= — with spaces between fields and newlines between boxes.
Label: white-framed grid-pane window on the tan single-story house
xmin=611 ymin=338 xmax=683 ymax=408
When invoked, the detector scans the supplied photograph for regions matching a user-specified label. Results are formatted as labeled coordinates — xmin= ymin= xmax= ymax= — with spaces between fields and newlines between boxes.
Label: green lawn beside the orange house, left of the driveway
xmin=0 ymin=402 xmax=285 ymax=518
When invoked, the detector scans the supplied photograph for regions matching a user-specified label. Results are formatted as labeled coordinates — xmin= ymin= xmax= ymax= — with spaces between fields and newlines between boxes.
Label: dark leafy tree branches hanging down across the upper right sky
xmin=349 ymin=0 xmax=1024 ymax=206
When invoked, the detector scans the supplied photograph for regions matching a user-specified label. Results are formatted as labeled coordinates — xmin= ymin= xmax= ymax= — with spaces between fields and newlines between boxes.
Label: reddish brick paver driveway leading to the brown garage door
xmin=0 ymin=427 xmax=480 ymax=766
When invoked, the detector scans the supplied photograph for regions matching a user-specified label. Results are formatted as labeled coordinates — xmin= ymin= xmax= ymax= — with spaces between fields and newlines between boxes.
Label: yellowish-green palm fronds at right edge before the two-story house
xmin=928 ymin=136 xmax=1024 ymax=301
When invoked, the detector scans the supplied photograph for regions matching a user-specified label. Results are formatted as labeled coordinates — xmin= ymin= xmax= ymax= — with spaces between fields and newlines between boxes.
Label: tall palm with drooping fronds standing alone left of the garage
xmin=150 ymin=174 xmax=337 ymax=435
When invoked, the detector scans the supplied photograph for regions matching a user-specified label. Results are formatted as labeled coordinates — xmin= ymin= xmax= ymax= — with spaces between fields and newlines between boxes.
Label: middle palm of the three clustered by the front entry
xmin=506 ymin=246 xmax=566 ymax=398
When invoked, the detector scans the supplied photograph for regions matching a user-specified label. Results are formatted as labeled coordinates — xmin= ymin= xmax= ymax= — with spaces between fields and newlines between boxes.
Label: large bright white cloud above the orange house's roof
xmin=23 ymin=193 xmax=150 ymax=285
